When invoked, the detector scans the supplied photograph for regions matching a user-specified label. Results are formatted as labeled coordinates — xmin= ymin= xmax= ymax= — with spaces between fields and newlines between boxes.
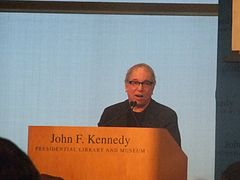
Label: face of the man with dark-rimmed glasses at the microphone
xmin=125 ymin=67 xmax=155 ymax=107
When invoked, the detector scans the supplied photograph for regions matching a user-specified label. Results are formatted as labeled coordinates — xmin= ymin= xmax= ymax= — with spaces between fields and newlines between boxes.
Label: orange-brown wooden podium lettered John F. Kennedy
xmin=28 ymin=126 xmax=187 ymax=180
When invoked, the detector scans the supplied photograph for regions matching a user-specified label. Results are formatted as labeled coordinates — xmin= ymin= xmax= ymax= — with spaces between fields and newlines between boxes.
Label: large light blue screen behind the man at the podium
xmin=0 ymin=13 xmax=218 ymax=180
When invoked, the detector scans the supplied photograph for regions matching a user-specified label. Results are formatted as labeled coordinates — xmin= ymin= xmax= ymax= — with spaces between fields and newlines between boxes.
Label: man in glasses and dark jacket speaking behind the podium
xmin=98 ymin=63 xmax=181 ymax=146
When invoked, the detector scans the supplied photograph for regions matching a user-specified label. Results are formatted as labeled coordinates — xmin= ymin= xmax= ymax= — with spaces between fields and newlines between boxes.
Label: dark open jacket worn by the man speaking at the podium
xmin=98 ymin=99 xmax=181 ymax=146
